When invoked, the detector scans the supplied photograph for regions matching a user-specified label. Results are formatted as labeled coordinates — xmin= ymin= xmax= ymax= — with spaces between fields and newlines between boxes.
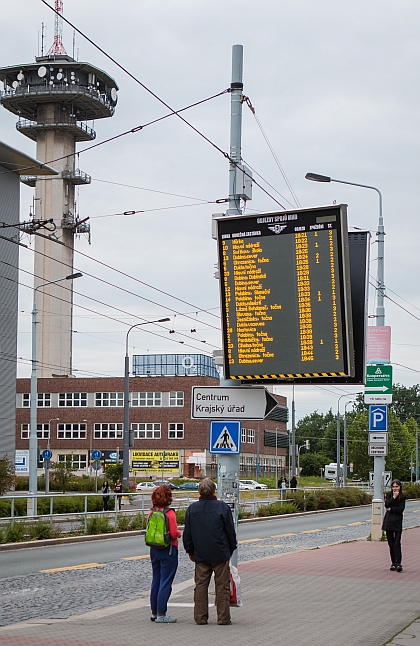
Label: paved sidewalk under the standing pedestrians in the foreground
xmin=0 ymin=528 xmax=420 ymax=646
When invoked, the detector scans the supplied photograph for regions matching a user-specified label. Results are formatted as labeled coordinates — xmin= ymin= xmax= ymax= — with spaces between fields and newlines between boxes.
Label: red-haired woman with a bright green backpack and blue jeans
xmin=149 ymin=485 xmax=181 ymax=624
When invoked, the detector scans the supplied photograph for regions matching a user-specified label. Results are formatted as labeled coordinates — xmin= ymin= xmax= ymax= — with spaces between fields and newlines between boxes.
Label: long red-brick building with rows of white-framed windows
xmin=16 ymin=375 xmax=287 ymax=477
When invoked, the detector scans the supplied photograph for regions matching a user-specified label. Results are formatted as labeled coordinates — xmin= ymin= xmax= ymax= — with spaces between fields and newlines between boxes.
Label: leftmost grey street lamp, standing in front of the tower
xmin=27 ymin=272 xmax=83 ymax=516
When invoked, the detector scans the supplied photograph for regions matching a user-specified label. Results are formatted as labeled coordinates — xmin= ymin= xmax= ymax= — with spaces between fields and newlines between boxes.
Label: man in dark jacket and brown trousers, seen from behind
xmin=182 ymin=478 xmax=237 ymax=625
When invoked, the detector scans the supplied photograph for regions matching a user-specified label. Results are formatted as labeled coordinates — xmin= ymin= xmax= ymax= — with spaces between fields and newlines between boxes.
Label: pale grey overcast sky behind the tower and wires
xmin=0 ymin=0 xmax=420 ymax=418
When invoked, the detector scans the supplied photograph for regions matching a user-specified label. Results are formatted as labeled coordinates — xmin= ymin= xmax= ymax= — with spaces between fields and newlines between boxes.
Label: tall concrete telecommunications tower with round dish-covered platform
xmin=0 ymin=0 xmax=118 ymax=377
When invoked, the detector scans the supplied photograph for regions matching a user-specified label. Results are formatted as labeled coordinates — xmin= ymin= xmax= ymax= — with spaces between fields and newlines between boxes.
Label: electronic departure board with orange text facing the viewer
xmin=217 ymin=205 xmax=354 ymax=383
